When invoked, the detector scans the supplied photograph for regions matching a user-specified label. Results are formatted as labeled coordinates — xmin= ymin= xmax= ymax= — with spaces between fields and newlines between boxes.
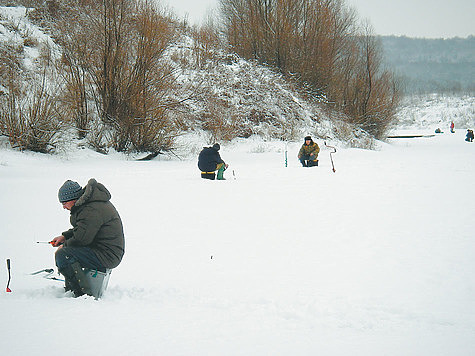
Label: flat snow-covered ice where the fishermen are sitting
xmin=0 ymin=129 xmax=475 ymax=356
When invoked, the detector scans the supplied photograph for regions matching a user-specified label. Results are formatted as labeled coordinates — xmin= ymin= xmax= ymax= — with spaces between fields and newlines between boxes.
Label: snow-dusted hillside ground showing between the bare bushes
xmin=0 ymin=7 xmax=380 ymax=154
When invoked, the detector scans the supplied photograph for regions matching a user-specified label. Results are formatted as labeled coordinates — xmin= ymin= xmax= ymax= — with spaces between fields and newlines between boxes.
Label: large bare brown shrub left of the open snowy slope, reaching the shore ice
xmin=50 ymin=0 xmax=178 ymax=151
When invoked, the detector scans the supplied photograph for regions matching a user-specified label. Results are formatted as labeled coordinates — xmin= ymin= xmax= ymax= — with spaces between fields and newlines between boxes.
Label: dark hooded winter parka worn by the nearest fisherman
xmin=63 ymin=179 xmax=125 ymax=268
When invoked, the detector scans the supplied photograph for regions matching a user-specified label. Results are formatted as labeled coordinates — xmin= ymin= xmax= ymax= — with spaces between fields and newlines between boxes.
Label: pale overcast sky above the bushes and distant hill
xmin=165 ymin=0 xmax=475 ymax=38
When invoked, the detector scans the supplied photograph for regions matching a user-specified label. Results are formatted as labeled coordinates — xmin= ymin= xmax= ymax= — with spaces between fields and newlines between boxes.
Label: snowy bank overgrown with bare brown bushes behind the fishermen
xmin=0 ymin=0 xmax=398 ymax=152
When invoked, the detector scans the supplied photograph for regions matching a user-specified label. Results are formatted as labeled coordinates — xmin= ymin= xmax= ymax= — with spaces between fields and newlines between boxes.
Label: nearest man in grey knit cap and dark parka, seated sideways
xmin=51 ymin=178 xmax=125 ymax=297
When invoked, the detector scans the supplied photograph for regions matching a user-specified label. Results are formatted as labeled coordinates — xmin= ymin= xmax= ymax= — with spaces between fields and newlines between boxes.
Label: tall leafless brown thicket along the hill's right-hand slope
xmin=220 ymin=0 xmax=399 ymax=137
